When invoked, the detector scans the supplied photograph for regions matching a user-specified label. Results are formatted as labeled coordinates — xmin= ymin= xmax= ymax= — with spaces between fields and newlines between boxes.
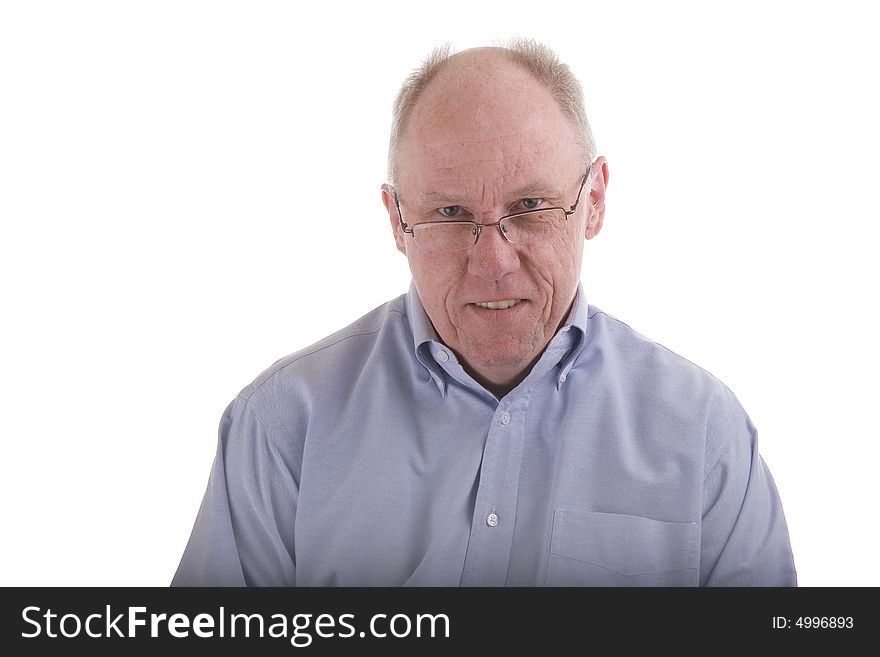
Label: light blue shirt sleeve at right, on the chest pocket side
xmin=700 ymin=395 xmax=797 ymax=586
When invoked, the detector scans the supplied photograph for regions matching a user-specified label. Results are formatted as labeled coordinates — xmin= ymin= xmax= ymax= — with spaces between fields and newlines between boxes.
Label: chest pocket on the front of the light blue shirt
xmin=546 ymin=509 xmax=699 ymax=586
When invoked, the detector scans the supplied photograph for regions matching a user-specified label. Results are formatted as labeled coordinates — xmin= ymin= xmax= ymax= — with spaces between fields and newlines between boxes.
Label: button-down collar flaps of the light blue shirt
xmin=406 ymin=281 xmax=587 ymax=397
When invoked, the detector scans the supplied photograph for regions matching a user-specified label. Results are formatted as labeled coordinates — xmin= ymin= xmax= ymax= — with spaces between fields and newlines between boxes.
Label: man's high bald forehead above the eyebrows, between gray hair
xmin=399 ymin=59 xmax=579 ymax=190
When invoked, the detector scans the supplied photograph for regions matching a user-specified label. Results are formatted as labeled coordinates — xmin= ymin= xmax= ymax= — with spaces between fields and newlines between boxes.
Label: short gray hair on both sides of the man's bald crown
xmin=388 ymin=38 xmax=596 ymax=183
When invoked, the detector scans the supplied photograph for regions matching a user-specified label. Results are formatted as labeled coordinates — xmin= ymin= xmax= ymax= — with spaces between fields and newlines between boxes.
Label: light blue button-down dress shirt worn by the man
xmin=172 ymin=286 xmax=796 ymax=586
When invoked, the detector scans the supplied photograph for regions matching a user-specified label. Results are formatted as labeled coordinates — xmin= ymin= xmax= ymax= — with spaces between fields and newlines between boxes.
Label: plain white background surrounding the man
xmin=0 ymin=0 xmax=880 ymax=586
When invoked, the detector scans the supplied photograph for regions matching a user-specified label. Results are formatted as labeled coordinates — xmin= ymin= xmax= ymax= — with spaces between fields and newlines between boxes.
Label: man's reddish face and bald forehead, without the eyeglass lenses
xmin=384 ymin=59 xmax=601 ymax=388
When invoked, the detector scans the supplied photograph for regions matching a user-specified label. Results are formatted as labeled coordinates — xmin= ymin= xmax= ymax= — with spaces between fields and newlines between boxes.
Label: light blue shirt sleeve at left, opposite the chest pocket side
xmin=171 ymin=396 xmax=299 ymax=586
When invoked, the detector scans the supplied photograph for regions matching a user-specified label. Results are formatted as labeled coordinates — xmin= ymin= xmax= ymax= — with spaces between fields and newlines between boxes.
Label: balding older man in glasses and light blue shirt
xmin=173 ymin=41 xmax=796 ymax=586
